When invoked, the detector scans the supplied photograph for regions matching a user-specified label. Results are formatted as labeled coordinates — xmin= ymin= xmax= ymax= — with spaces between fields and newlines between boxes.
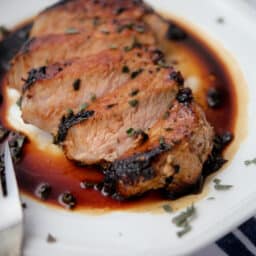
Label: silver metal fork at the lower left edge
xmin=0 ymin=142 xmax=23 ymax=256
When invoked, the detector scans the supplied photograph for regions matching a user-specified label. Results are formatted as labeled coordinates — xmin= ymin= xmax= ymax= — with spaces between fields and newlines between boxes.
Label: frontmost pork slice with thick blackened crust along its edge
xmin=103 ymin=97 xmax=214 ymax=197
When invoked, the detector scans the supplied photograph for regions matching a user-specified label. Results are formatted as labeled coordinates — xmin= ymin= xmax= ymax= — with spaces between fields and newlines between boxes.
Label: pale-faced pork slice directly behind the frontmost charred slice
xmin=62 ymin=65 xmax=179 ymax=164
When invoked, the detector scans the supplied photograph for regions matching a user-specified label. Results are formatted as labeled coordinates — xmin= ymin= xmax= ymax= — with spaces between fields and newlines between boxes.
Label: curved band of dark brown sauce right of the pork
xmin=167 ymin=23 xmax=237 ymax=134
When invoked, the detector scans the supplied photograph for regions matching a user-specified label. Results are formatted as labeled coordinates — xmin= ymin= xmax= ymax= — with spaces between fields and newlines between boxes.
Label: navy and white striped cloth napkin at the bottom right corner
xmin=197 ymin=218 xmax=256 ymax=256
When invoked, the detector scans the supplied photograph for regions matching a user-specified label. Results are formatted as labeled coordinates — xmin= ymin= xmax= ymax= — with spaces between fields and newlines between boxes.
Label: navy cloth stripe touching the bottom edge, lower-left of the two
xmin=216 ymin=233 xmax=254 ymax=256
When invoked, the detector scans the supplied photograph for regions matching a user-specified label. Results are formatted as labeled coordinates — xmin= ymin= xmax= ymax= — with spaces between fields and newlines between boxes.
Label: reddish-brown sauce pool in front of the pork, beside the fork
xmin=16 ymin=143 xmax=166 ymax=209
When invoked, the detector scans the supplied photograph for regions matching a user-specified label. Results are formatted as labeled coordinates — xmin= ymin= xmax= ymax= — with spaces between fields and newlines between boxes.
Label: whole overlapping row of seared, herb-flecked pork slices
xmin=11 ymin=0 xmax=213 ymax=197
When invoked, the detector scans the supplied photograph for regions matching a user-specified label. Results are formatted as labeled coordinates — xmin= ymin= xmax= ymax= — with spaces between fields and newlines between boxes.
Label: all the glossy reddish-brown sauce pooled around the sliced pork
xmin=0 ymin=19 xmax=236 ymax=209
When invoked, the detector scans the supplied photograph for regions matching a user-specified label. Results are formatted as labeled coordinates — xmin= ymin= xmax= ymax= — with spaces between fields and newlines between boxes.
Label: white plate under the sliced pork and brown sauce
xmin=0 ymin=0 xmax=256 ymax=256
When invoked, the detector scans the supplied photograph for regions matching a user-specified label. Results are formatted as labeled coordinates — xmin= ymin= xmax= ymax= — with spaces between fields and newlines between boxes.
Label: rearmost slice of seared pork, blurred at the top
xmin=31 ymin=0 xmax=172 ymax=51
